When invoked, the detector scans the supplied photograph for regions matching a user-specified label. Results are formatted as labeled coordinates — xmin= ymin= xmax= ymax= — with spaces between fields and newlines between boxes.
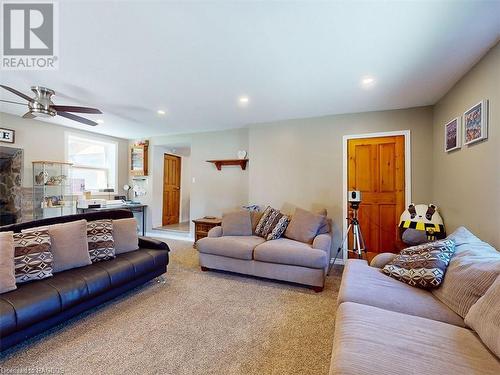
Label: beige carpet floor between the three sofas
xmin=0 ymin=240 xmax=341 ymax=375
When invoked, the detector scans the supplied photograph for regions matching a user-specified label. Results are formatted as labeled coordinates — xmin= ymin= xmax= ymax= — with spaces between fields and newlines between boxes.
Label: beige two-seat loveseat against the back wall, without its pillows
xmin=196 ymin=227 xmax=332 ymax=292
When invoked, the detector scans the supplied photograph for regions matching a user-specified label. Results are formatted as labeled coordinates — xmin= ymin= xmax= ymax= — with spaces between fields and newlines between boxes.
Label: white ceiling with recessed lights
xmin=0 ymin=0 xmax=500 ymax=138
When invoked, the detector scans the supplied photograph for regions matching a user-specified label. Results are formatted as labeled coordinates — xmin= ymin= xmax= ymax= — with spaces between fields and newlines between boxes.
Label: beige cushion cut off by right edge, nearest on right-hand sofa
xmin=465 ymin=277 xmax=500 ymax=358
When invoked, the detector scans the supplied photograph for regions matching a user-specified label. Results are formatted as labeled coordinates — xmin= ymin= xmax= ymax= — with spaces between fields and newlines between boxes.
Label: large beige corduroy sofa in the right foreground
xmin=330 ymin=228 xmax=500 ymax=375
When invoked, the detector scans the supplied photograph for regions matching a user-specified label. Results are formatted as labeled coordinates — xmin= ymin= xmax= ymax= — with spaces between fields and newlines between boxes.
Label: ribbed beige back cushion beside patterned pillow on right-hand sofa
xmin=432 ymin=227 xmax=500 ymax=317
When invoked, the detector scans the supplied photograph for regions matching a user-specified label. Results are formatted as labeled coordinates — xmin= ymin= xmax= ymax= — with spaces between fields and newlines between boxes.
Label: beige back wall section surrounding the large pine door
xmin=249 ymin=107 xmax=432 ymax=251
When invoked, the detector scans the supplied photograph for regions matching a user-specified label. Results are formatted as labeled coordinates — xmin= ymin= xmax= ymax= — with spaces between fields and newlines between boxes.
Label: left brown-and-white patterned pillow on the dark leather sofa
xmin=13 ymin=230 xmax=53 ymax=284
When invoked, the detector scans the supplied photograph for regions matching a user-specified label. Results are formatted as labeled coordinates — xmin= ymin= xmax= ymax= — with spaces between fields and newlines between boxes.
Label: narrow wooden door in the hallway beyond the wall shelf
xmin=162 ymin=154 xmax=181 ymax=225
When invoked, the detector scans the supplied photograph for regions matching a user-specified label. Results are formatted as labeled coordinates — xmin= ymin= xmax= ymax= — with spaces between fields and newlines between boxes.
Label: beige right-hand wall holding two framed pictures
xmin=432 ymin=44 xmax=500 ymax=249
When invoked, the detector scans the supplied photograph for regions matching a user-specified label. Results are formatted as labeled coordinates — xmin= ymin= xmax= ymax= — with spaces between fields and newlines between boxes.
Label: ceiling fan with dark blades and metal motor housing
xmin=0 ymin=85 xmax=102 ymax=126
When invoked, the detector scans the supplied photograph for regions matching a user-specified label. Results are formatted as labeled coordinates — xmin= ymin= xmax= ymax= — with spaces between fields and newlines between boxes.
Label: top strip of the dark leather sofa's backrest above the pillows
xmin=0 ymin=209 xmax=134 ymax=233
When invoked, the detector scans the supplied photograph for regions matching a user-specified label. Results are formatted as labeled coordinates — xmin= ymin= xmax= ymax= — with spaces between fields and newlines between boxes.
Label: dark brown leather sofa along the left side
xmin=0 ymin=210 xmax=169 ymax=351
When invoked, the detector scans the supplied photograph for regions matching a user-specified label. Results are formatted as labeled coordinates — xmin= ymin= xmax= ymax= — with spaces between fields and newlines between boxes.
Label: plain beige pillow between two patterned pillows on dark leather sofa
xmin=49 ymin=220 xmax=92 ymax=272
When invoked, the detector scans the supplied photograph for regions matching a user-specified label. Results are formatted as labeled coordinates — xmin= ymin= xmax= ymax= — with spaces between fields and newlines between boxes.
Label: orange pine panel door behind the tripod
xmin=347 ymin=135 xmax=405 ymax=259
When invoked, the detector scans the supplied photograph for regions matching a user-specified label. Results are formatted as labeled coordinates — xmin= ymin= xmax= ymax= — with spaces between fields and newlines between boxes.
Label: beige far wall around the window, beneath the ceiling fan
xmin=0 ymin=112 xmax=128 ymax=195
